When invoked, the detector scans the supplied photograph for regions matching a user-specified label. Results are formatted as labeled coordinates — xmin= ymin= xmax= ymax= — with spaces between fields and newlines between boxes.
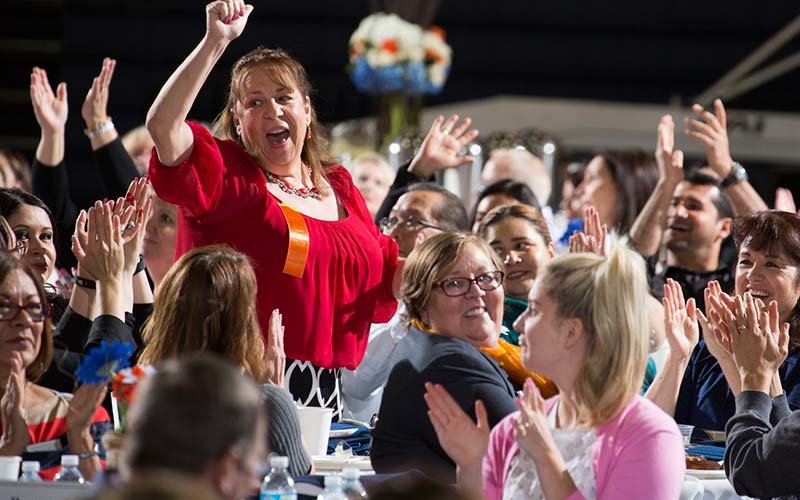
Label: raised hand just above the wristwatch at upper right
xmin=686 ymin=99 xmax=733 ymax=179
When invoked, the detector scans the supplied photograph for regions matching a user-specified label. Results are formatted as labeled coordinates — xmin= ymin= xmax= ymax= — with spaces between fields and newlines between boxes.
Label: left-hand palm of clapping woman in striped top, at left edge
xmin=0 ymin=352 xmax=30 ymax=455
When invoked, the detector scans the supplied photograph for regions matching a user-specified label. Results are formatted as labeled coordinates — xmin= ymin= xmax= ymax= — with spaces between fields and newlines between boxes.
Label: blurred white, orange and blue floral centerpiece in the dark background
xmin=349 ymin=12 xmax=452 ymax=147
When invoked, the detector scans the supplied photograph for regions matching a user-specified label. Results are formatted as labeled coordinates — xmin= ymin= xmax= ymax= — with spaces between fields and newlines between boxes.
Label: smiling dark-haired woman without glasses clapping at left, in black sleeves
xmin=0 ymin=184 xmax=152 ymax=392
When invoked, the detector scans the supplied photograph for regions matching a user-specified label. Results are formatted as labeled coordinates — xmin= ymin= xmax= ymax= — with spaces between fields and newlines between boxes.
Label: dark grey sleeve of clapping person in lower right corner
xmin=724 ymin=391 xmax=800 ymax=498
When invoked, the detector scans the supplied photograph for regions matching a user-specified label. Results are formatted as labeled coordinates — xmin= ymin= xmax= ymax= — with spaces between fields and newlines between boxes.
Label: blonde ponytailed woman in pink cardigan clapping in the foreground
xmin=425 ymin=244 xmax=685 ymax=500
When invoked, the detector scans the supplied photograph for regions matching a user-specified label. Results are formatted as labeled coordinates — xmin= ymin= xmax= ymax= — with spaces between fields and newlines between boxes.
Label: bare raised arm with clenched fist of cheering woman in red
xmin=146 ymin=0 xmax=253 ymax=165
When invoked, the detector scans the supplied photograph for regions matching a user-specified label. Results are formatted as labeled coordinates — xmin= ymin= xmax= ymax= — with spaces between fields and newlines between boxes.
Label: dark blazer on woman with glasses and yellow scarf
xmin=370 ymin=327 xmax=517 ymax=482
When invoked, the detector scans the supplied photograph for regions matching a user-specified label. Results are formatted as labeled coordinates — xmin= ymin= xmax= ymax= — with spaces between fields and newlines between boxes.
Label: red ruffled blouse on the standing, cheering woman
xmin=149 ymin=122 xmax=398 ymax=369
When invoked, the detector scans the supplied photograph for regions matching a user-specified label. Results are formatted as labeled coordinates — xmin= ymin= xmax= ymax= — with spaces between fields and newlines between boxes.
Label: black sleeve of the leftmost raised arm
xmin=31 ymin=158 xmax=78 ymax=269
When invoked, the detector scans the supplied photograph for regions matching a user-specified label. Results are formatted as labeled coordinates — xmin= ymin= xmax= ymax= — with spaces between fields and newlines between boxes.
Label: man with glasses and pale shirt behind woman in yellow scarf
xmin=341 ymin=182 xmax=469 ymax=423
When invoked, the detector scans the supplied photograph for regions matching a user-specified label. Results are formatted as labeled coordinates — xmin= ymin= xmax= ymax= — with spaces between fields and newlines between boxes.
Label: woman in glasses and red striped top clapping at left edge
xmin=0 ymin=252 xmax=110 ymax=480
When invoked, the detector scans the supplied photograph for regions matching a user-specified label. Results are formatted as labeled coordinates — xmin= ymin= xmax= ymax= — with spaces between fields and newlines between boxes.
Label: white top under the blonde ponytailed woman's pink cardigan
xmin=503 ymin=403 xmax=597 ymax=500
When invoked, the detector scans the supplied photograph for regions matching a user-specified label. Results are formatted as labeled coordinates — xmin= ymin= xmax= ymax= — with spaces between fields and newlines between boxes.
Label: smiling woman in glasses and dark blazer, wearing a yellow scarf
xmin=370 ymin=233 xmax=515 ymax=482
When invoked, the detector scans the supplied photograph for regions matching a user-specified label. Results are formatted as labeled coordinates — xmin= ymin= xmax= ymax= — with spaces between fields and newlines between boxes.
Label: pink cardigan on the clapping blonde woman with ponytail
xmin=483 ymin=396 xmax=686 ymax=500
